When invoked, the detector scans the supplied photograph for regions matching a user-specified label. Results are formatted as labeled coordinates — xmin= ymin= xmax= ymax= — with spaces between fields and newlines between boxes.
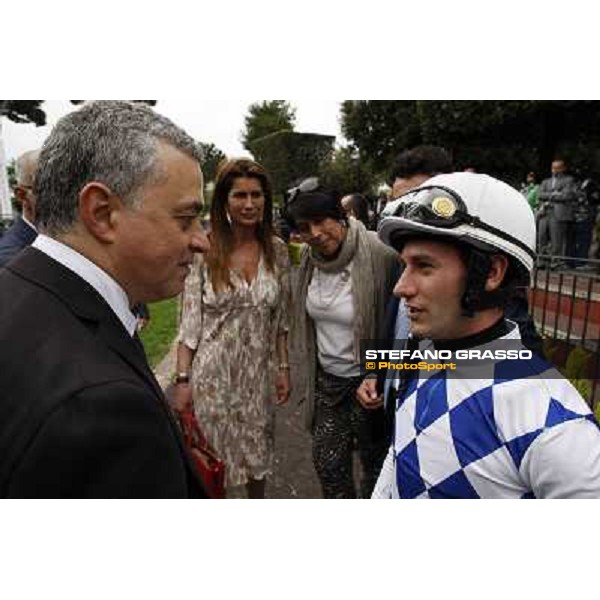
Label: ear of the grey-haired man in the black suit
xmin=79 ymin=181 xmax=123 ymax=244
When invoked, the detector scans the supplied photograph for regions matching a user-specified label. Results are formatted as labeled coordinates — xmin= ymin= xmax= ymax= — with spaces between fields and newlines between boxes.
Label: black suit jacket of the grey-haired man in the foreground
xmin=0 ymin=248 xmax=205 ymax=498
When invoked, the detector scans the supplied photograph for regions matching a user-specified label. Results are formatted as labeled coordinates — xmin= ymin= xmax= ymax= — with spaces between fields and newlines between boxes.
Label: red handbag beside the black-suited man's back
xmin=178 ymin=409 xmax=225 ymax=499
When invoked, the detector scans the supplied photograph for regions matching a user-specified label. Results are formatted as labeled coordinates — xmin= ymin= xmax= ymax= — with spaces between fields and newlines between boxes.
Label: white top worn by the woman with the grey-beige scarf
xmin=306 ymin=262 xmax=360 ymax=377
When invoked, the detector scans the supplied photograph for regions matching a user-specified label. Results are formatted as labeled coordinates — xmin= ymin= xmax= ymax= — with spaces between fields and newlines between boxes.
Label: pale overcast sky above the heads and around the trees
xmin=2 ymin=100 xmax=341 ymax=160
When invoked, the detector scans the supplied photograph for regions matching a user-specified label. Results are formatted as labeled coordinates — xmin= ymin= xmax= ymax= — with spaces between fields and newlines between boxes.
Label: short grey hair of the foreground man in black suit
xmin=34 ymin=100 xmax=202 ymax=235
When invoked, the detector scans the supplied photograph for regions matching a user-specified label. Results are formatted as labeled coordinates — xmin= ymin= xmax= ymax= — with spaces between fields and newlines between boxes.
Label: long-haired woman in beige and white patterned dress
xmin=175 ymin=159 xmax=290 ymax=498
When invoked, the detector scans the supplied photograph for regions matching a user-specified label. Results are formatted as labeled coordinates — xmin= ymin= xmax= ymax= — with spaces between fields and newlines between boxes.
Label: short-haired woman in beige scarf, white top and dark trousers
xmin=287 ymin=178 xmax=398 ymax=498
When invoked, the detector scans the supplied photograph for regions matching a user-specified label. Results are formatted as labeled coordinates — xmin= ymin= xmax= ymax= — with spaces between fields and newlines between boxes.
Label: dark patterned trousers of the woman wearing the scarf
xmin=313 ymin=368 xmax=390 ymax=498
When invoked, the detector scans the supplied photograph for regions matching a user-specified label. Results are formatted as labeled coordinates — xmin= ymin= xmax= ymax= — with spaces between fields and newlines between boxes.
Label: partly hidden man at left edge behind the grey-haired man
xmin=0 ymin=150 xmax=39 ymax=267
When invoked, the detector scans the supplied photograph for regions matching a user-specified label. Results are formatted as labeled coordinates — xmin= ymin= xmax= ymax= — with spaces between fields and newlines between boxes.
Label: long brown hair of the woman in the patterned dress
xmin=206 ymin=158 xmax=275 ymax=292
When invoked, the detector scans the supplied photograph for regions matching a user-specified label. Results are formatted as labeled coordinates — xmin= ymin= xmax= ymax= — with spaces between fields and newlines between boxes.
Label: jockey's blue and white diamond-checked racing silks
xmin=373 ymin=327 xmax=600 ymax=498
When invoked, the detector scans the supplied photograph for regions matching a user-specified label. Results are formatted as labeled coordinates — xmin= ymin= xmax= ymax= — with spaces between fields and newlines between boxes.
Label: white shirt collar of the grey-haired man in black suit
xmin=31 ymin=234 xmax=137 ymax=336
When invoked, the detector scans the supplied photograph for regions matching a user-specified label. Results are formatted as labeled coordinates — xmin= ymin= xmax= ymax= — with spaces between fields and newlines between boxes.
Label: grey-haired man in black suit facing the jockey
xmin=0 ymin=101 xmax=208 ymax=498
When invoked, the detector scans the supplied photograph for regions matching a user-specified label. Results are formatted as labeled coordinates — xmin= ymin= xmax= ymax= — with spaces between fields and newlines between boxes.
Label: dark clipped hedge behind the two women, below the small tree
xmin=248 ymin=131 xmax=335 ymax=192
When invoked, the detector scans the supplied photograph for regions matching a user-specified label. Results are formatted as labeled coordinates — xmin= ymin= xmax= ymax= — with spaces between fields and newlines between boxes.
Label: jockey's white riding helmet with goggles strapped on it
xmin=378 ymin=172 xmax=536 ymax=273
